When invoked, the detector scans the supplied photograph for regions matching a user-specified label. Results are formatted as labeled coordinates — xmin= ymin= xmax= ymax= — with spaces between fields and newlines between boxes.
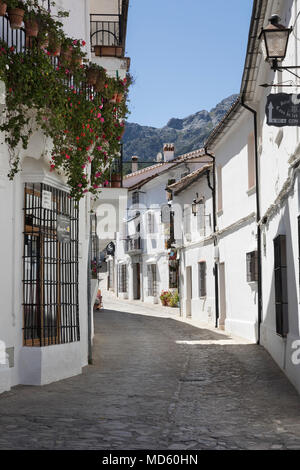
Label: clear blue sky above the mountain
xmin=126 ymin=0 xmax=252 ymax=127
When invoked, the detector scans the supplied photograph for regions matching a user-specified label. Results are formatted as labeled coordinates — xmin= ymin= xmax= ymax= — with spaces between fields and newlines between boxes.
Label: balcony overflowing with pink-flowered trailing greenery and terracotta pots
xmin=0 ymin=0 xmax=130 ymax=201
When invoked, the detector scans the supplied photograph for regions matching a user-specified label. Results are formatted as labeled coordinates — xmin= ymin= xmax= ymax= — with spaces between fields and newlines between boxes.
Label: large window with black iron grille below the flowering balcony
xmin=23 ymin=183 xmax=80 ymax=346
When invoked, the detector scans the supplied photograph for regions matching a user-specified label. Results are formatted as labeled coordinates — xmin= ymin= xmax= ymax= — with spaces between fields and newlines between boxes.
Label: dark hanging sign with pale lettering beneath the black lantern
xmin=266 ymin=93 xmax=300 ymax=127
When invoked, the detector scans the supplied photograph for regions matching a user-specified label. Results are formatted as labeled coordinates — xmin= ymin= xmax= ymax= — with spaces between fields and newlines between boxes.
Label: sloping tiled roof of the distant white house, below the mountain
xmin=123 ymin=149 xmax=205 ymax=190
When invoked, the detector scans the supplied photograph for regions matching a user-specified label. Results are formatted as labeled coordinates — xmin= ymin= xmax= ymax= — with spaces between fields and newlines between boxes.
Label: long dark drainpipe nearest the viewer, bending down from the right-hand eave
xmin=240 ymin=96 xmax=262 ymax=344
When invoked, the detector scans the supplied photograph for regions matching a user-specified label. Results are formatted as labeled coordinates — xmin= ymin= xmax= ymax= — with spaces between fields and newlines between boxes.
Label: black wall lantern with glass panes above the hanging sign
xmin=259 ymin=15 xmax=292 ymax=70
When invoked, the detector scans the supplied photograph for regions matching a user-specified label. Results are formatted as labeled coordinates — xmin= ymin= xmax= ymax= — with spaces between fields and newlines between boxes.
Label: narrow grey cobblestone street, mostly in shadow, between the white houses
xmin=0 ymin=302 xmax=300 ymax=450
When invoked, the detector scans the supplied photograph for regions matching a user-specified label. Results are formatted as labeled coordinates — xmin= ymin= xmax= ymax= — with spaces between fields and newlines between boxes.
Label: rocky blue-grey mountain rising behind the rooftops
xmin=123 ymin=95 xmax=238 ymax=162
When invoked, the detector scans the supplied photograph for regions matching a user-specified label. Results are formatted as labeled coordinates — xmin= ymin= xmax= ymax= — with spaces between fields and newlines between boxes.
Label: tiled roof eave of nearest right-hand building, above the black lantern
xmin=204 ymin=0 xmax=268 ymax=148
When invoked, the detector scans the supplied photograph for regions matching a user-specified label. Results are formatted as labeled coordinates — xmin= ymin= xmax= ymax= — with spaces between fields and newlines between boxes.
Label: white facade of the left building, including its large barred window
xmin=0 ymin=0 xmax=128 ymax=393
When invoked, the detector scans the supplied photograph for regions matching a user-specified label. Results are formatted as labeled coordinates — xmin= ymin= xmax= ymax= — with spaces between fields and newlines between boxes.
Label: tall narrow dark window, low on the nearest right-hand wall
xmin=274 ymin=235 xmax=288 ymax=337
